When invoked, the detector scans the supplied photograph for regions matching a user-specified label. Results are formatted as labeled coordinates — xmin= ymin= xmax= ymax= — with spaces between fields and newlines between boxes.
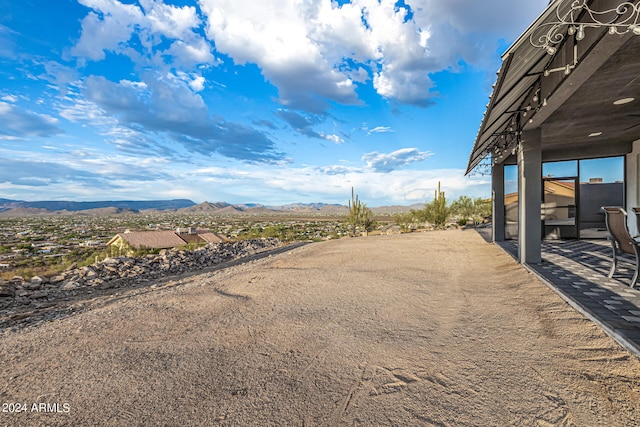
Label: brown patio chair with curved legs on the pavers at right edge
xmin=602 ymin=206 xmax=640 ymax=288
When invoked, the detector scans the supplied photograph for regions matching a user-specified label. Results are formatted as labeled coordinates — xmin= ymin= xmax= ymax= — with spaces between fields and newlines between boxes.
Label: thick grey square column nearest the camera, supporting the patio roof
xmin=518 ymin=128 xmax=542 ymax=264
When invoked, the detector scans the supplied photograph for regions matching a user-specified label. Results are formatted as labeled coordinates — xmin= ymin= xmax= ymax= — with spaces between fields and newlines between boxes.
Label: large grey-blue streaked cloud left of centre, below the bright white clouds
xmin=77 ymin=73 xmax=285 ymax=163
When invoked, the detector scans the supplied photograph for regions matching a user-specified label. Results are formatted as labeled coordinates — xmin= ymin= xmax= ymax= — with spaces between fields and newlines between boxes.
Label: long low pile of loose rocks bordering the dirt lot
xmin=0 ymin=238 xmax=282 ymax=310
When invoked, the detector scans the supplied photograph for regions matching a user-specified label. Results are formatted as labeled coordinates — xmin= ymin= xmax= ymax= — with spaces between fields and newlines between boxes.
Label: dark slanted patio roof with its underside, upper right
xmin=466 ymin=0 xmax=640 ymax=174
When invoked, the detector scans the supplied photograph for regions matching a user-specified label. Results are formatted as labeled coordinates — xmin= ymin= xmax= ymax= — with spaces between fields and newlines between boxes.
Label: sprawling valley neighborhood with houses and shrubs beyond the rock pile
xmin=0 ymin=212 xmax=364 ymax=279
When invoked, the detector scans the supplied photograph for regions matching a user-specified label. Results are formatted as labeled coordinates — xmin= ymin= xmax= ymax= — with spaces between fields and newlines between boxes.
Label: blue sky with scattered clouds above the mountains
xmin=0 ymin=0 xmax=548 ymax=206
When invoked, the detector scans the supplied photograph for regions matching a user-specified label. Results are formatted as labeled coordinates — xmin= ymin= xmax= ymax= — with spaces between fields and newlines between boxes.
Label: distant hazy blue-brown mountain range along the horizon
xmin=0 ymin=198 xmax=423 ymax=216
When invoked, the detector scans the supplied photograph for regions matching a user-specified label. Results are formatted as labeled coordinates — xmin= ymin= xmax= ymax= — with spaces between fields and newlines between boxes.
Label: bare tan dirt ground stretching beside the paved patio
xmin=0 ymin=231 xmax=640 ymax=426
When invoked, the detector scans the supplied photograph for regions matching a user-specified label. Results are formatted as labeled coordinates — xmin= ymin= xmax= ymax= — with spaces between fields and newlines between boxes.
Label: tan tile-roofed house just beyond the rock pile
xmin=107 ymin=229 xmax=229 ymax=251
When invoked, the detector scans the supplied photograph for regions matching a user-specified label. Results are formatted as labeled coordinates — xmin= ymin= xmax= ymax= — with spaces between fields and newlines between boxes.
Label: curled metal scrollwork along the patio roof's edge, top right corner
xmin=529 ymin=0 xmax=640 ymax=55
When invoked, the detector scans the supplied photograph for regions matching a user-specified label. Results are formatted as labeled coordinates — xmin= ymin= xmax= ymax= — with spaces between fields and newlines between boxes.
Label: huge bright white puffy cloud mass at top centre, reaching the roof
xmin=199 ymin=0 xmax=545 ymax=112
